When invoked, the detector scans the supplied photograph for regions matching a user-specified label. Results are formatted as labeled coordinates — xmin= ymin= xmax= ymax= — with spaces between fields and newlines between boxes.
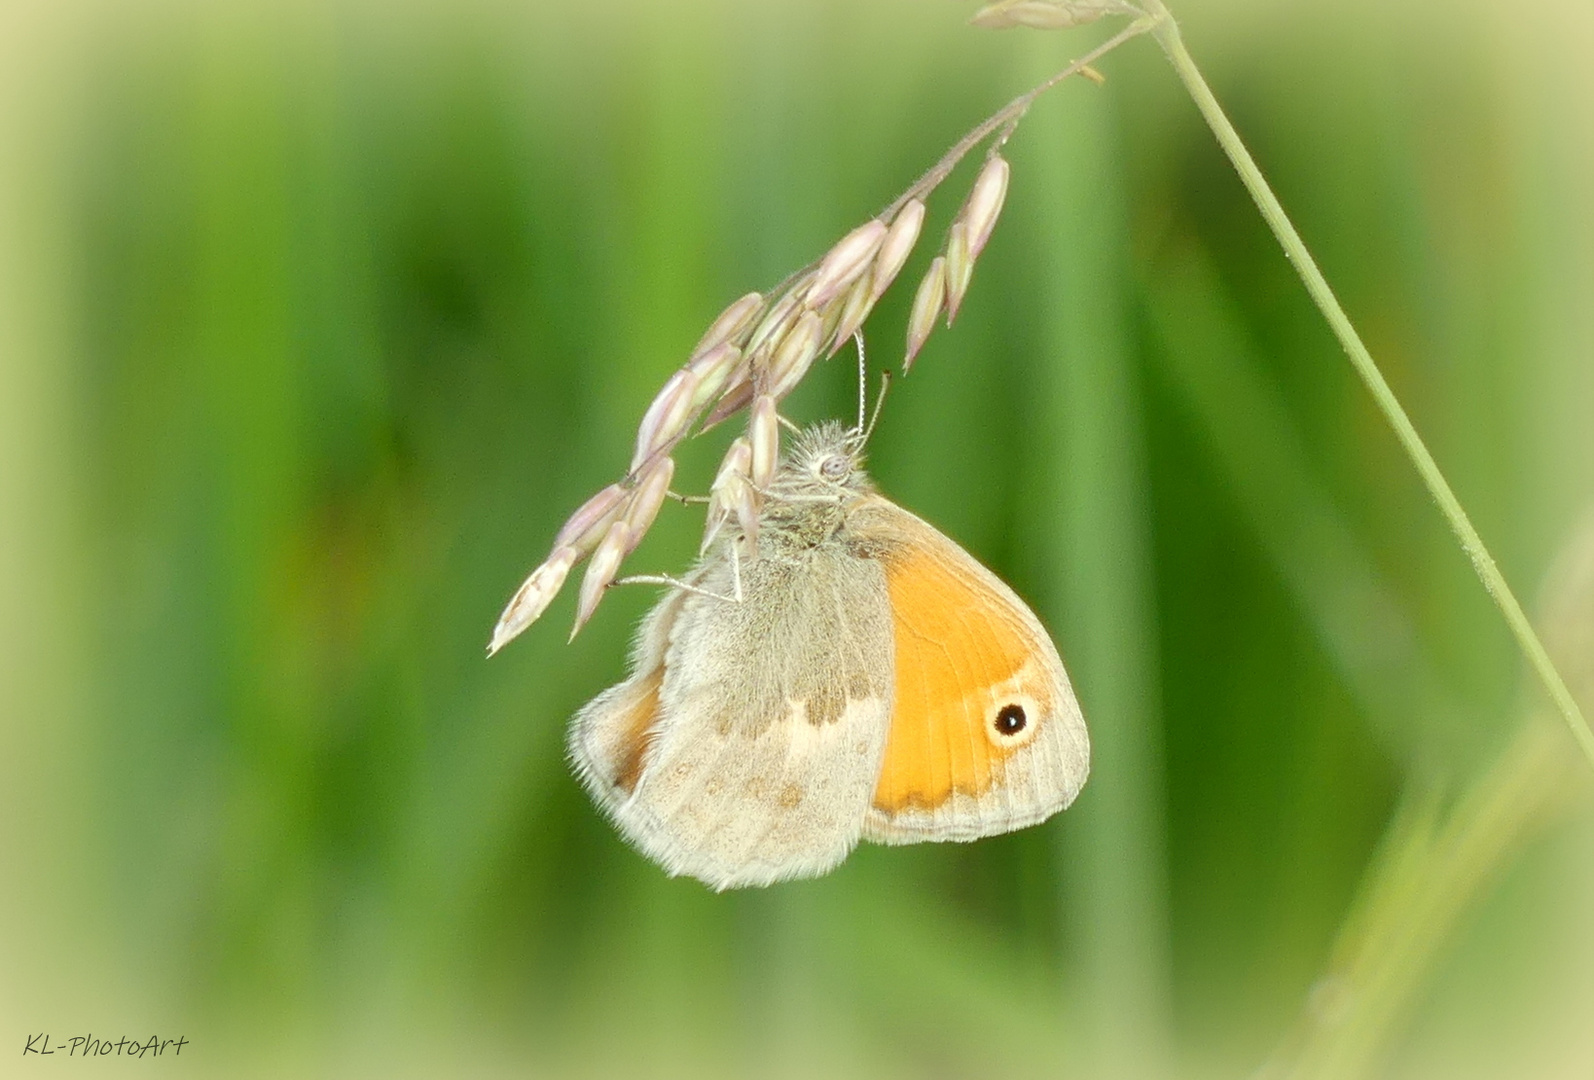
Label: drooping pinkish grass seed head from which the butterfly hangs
xmin=488 ymin=8 xmax=1146 ymax=655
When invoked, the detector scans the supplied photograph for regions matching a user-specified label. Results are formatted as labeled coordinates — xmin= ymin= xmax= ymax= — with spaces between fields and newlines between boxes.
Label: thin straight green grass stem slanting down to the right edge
xmin=1148 ymin=0 xmax=1594 ymax=777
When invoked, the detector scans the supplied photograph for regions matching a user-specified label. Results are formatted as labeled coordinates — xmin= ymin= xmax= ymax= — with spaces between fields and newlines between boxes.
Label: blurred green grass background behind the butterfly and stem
xmin=9 ymin=0 xmax=1594 ymax=1078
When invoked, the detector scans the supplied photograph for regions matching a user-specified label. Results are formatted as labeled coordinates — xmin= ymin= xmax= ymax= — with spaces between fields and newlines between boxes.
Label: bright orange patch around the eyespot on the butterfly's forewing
xmin=874 ymin=545 xmax=1055 ymax=814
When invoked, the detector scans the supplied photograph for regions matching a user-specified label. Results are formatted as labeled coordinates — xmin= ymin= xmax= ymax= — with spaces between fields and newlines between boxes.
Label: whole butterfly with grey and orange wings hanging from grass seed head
xmin=569 ymin=422 xmax=1090 ymax=890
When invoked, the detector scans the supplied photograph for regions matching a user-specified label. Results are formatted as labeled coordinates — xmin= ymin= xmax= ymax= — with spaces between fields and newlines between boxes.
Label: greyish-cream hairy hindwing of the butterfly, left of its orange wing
xmin=571 ymin=545 xmax=893 ymax=889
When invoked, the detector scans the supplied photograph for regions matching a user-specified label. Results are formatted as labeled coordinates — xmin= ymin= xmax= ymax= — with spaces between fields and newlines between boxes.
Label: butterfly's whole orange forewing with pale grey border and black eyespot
xmin=848 ymin=499 xmax=1090 ymax=844
